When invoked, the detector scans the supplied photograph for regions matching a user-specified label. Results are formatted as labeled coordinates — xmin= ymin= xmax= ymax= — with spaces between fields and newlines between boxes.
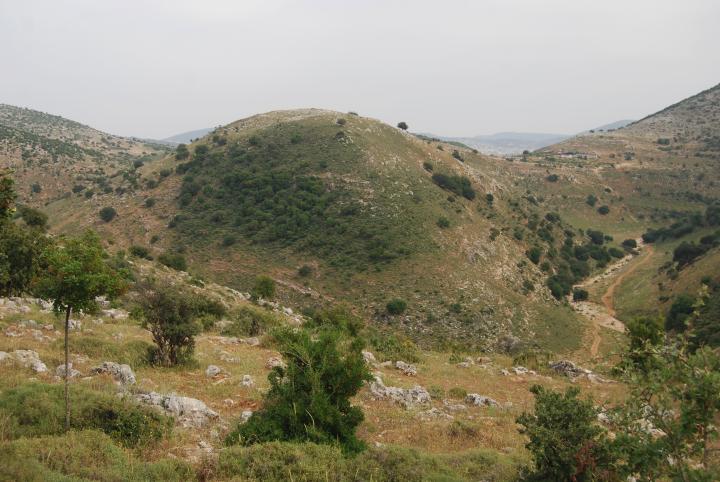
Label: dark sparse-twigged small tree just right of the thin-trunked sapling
xmin=138 ymin=282 xmax=200 ymax=367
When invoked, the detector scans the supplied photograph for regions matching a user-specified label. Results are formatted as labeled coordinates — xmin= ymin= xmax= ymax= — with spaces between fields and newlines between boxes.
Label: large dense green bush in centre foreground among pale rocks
xmin=227 ymin=329 xmax=370 ymax=453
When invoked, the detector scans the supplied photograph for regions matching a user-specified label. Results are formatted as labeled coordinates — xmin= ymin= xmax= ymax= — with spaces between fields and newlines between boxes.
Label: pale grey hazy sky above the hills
xmin=0 ymin=0 xmax=720 ymax=138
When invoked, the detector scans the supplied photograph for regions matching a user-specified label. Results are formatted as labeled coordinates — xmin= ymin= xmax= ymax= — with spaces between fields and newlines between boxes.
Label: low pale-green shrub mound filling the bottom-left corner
xmin=0 ymin=430 xmax=195 ymax=482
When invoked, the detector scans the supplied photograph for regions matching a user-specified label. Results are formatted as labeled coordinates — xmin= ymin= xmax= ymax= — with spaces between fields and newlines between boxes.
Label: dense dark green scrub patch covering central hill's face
xmin=172 ymin=122 xmax=419 ymax=270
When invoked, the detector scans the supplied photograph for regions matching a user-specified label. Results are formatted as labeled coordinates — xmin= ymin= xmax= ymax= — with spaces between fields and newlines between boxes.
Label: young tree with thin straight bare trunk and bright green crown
xmin=35 ymin=231 xmax=125 ymax=430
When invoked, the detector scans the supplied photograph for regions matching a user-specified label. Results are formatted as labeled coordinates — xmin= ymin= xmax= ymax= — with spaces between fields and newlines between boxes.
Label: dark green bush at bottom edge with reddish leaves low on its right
xmin=517 ymin=385 xmax=613 ymax=481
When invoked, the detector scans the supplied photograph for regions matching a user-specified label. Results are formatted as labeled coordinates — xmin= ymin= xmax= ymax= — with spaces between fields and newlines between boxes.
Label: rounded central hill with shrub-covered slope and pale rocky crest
xmin=14 ymin=109 xmax=612 ymax=351
